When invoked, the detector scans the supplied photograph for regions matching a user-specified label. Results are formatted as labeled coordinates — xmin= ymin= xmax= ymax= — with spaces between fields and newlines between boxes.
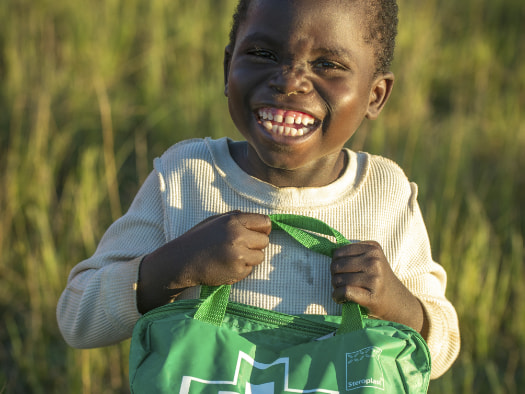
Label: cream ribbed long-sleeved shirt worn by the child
xmin=57 ymin=138 xmax=460 ymax=378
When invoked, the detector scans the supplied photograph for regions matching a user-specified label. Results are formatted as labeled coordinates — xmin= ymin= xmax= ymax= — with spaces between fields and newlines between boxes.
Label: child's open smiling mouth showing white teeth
xmin=257 ymin=108 xmax=316 ymax=137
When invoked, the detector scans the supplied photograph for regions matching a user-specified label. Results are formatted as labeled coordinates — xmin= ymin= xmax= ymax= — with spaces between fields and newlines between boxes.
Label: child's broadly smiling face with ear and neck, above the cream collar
xmin=225 ymin=0 xmax=393 ymax=186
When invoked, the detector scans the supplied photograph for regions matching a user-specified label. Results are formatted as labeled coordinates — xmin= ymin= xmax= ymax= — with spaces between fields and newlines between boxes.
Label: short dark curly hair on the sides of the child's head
xmin=229 ymin=0 xmax=398 ymax=74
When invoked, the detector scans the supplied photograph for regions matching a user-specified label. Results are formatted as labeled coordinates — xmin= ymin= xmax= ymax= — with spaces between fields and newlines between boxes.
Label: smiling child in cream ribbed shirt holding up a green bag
xmin=57 ymin=0 xmax=459 ymax=378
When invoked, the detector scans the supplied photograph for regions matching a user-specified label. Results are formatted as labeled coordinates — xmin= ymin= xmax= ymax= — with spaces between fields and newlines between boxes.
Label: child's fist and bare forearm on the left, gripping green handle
xmin=137 ymin=211 xmax=272 ymax=313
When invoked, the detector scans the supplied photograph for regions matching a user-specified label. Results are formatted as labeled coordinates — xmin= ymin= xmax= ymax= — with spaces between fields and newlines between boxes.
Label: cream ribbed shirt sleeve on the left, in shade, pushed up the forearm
xmin=57 ymin=172 xmax=166 ymax=348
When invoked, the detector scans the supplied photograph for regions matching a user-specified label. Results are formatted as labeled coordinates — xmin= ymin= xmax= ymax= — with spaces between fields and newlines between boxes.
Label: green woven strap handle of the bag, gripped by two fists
xmin=194 ymin=214 xmax=366 ymax=335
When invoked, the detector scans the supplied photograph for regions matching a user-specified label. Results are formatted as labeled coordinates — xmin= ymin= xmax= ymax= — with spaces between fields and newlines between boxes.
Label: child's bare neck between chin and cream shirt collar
xmin=229 ymin=141 xmax=348 ymax=187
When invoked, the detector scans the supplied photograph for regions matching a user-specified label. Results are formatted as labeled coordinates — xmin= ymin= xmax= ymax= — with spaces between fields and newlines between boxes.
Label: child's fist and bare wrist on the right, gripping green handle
xmin=331 ymin=241 xmax=426 ymax=332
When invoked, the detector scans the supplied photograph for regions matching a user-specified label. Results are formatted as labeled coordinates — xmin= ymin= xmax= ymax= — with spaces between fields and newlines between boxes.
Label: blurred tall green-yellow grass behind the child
xmin=0 ymin=0 xmax=525 ymax=393
